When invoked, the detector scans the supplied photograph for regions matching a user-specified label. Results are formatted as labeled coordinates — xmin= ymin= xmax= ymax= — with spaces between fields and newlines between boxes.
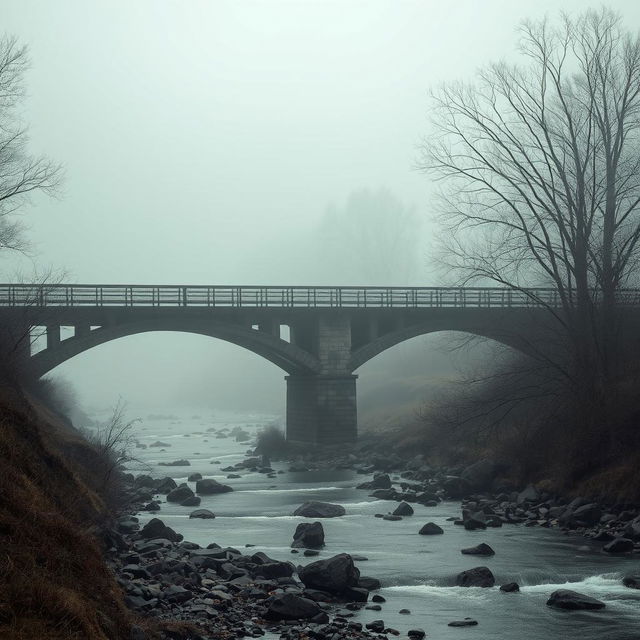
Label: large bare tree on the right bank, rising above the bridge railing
xmin=421 ymin=8 xmax=640 ymax=432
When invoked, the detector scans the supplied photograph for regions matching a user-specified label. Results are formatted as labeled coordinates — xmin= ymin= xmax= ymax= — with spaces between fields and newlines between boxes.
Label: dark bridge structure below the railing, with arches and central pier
xmin=1 ymin=307 xmax=552 ymax=445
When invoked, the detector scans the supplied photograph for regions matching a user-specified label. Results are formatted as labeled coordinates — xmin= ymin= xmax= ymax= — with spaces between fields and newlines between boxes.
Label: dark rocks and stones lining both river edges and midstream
xmin=107 ymin=442 xmax=640 ymax=640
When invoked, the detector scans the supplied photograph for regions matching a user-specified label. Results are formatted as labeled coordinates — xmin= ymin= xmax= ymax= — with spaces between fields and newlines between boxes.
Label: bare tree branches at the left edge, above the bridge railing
xmin=0 ymin=35 xmax=62 ymax=251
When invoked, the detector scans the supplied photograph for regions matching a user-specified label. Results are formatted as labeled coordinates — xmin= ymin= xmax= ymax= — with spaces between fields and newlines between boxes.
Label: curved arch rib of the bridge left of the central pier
xmin=29 ymin=319 xmax=320 ymax=377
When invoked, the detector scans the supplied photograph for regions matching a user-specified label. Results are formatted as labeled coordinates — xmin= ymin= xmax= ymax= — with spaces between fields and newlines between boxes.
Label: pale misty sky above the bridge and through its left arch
xmin=0 ymin=0 xmax=640 ymax=416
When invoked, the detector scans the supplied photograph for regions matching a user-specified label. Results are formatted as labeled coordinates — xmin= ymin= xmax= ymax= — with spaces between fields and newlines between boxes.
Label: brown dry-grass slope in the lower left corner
xmin=0 ymin=391 xmax=131 ymax=640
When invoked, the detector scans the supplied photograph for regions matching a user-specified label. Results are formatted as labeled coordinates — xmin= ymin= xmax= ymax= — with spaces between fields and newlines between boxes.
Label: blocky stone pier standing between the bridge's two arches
xmin=286 ymin=375 xmax=358 ymax=444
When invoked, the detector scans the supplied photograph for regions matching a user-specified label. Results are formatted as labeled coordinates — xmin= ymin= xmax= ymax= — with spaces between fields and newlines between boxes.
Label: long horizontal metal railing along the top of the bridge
xmin=0 ymin=284 xmax=640 ymax=309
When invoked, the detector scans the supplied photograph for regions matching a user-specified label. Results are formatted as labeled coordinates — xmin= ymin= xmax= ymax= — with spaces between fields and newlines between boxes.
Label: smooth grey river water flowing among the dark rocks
xmin=117 ymin=414 xmax=640 ymax=640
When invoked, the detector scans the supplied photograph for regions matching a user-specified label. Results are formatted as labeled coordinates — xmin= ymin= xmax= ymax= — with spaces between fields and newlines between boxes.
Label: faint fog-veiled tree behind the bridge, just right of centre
xmin=316 ymin=189 xmax=420 ymax=285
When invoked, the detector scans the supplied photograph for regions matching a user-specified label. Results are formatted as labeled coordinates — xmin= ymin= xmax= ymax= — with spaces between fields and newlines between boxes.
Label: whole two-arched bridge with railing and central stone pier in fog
xmin=0 ymin=284 xmax=640 ymax=444
